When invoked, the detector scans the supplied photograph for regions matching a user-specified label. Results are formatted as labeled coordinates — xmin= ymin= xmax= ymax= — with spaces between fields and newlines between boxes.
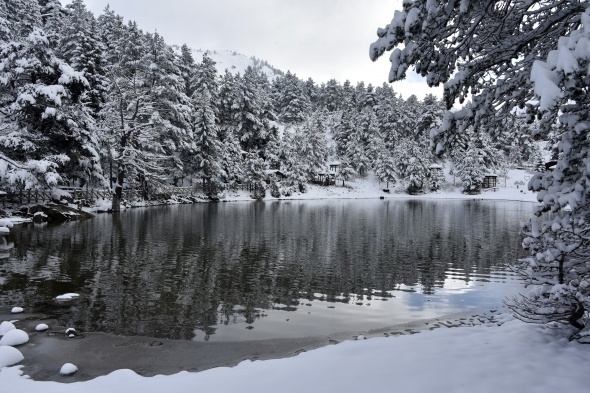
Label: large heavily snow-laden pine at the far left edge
xmin=0 ymin=1 xmax=101 ymax=188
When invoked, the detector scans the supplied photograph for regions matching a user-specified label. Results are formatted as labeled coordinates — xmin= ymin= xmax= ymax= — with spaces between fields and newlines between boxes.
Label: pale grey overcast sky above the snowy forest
xmin=61 ymin=0 xmax=441 ymax=98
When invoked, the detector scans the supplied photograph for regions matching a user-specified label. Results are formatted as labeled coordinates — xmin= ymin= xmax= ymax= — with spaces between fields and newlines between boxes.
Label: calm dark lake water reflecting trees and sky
xmin=0 ymin=200 xmax=533 ymax=340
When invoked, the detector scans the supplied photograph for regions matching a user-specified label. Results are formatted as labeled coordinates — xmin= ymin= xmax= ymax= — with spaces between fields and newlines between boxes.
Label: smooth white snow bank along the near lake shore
xmin=0 ymin=315 xmax=590 ymax=393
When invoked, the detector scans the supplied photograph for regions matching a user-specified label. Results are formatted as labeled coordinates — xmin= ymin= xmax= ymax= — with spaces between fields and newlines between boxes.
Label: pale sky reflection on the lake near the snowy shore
xmin=193 ymin=276 xmax=522 ymax=341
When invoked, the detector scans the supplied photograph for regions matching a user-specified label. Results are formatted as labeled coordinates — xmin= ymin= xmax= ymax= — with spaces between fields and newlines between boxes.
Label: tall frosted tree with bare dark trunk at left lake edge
xmin=101 ymin=19 xmax=169 ymax=211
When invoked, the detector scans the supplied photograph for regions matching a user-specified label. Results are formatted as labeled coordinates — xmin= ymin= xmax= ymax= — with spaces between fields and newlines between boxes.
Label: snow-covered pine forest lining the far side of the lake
xmin=0 ymin=0 xmax=544 ymax=207
